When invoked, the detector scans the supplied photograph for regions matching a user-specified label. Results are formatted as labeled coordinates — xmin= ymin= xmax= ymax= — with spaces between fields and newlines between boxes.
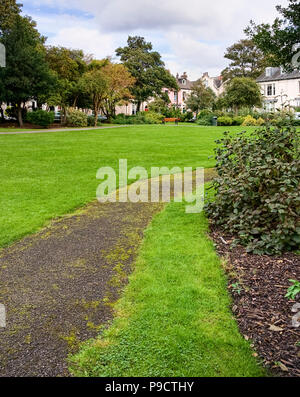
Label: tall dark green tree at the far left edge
xmin=0 ymin=15 xmax=54 ymax=126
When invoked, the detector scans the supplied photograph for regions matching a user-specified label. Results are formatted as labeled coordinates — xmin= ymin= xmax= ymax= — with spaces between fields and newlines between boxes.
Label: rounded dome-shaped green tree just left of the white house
xmin=225 ymin=77 xmax=262 ymax=110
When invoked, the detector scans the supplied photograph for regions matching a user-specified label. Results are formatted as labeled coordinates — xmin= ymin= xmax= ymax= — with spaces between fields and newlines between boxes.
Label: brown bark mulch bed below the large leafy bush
xmin=211 ymin=228 xmax=300 ymax=377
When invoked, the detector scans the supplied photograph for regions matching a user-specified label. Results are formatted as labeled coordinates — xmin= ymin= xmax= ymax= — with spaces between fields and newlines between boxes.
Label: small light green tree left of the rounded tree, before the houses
xmin=186 ymin=80 xmax=216 ymax=113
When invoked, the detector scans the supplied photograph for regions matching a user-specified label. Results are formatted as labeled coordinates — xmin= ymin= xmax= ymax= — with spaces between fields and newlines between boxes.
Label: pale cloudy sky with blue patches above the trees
xmin=22 ymin=0 xmax=288 ymax=80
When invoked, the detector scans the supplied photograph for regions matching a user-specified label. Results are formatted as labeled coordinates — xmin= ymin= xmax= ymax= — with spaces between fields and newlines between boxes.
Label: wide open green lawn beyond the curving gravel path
xmin=0 ymin=125 xmax=255 ymax=247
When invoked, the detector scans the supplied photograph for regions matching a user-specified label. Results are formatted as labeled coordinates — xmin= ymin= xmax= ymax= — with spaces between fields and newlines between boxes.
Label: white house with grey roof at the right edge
xmin=256 ymin=67 xmax=300 ymax=111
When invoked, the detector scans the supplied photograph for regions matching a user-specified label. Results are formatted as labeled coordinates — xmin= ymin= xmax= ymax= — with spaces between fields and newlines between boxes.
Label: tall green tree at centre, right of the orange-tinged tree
xmin=116 ymin=36 xmax=178 ymax=111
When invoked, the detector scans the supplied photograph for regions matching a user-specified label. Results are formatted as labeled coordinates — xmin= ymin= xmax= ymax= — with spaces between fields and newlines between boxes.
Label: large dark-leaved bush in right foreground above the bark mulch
xmin=206 ymin=128 xmax=300 ymax=254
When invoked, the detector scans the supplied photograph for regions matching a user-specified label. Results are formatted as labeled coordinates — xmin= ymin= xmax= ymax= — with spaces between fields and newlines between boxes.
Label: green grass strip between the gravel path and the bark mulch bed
xmin=71 ymin=203 xmax=265 ymax=377
